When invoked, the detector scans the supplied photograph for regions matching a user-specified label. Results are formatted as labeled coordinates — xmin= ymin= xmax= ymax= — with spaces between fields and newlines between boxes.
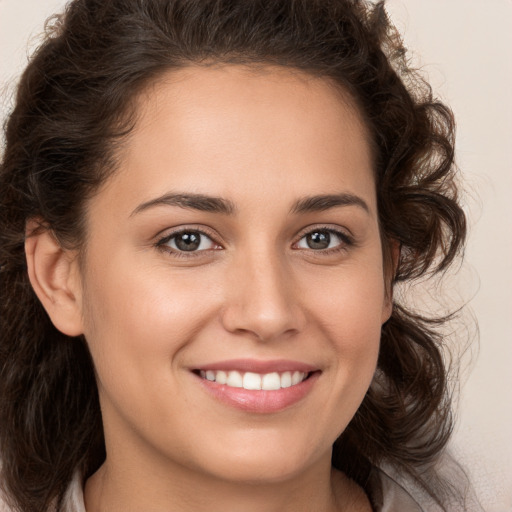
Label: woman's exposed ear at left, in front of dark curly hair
xmin=25 ymin=220 xmax=83 ymax=336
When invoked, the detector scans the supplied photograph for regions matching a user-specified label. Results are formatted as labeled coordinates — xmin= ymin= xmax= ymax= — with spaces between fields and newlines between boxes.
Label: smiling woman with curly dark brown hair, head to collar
xmin=0 ymin=0 xmax=480 ymax=512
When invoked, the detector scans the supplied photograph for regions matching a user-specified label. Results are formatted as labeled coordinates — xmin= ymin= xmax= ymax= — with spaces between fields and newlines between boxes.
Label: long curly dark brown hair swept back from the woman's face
xmin=0 ymin=0 xmax=466 ymax=512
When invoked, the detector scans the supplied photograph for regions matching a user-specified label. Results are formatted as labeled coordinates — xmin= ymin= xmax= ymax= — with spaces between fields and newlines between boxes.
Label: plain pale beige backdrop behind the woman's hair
xmin=0 ymin=0 xmax=512 ymax=512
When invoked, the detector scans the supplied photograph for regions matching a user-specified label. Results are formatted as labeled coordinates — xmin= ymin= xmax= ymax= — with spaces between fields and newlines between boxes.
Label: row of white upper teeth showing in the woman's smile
xmin=199 ymin=370 xmax=307 ymax=391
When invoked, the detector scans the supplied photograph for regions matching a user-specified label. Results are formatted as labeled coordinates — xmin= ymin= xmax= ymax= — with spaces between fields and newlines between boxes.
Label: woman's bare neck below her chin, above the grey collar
xmin=85 ymin=457 xmax=370 ymax=512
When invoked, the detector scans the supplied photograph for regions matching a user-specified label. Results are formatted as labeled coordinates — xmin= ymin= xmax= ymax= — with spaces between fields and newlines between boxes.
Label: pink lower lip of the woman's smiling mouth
xmin=197 ymin=372 xmax=320 ymax=414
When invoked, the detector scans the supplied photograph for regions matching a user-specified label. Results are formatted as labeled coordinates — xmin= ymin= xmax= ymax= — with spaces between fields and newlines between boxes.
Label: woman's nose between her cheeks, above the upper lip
xmin=222 ymin=249 xmax=305 ymax=341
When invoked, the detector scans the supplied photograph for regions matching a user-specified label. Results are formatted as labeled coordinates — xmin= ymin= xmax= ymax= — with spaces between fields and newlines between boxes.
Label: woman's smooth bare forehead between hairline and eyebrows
xmin=102 ymin=65 xmax=373 ymax=212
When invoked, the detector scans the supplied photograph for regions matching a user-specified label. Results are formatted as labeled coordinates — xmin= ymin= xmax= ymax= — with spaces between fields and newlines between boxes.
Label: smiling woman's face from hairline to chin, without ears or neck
xmin=76 ymin=66 xmax=390 ymax=481
